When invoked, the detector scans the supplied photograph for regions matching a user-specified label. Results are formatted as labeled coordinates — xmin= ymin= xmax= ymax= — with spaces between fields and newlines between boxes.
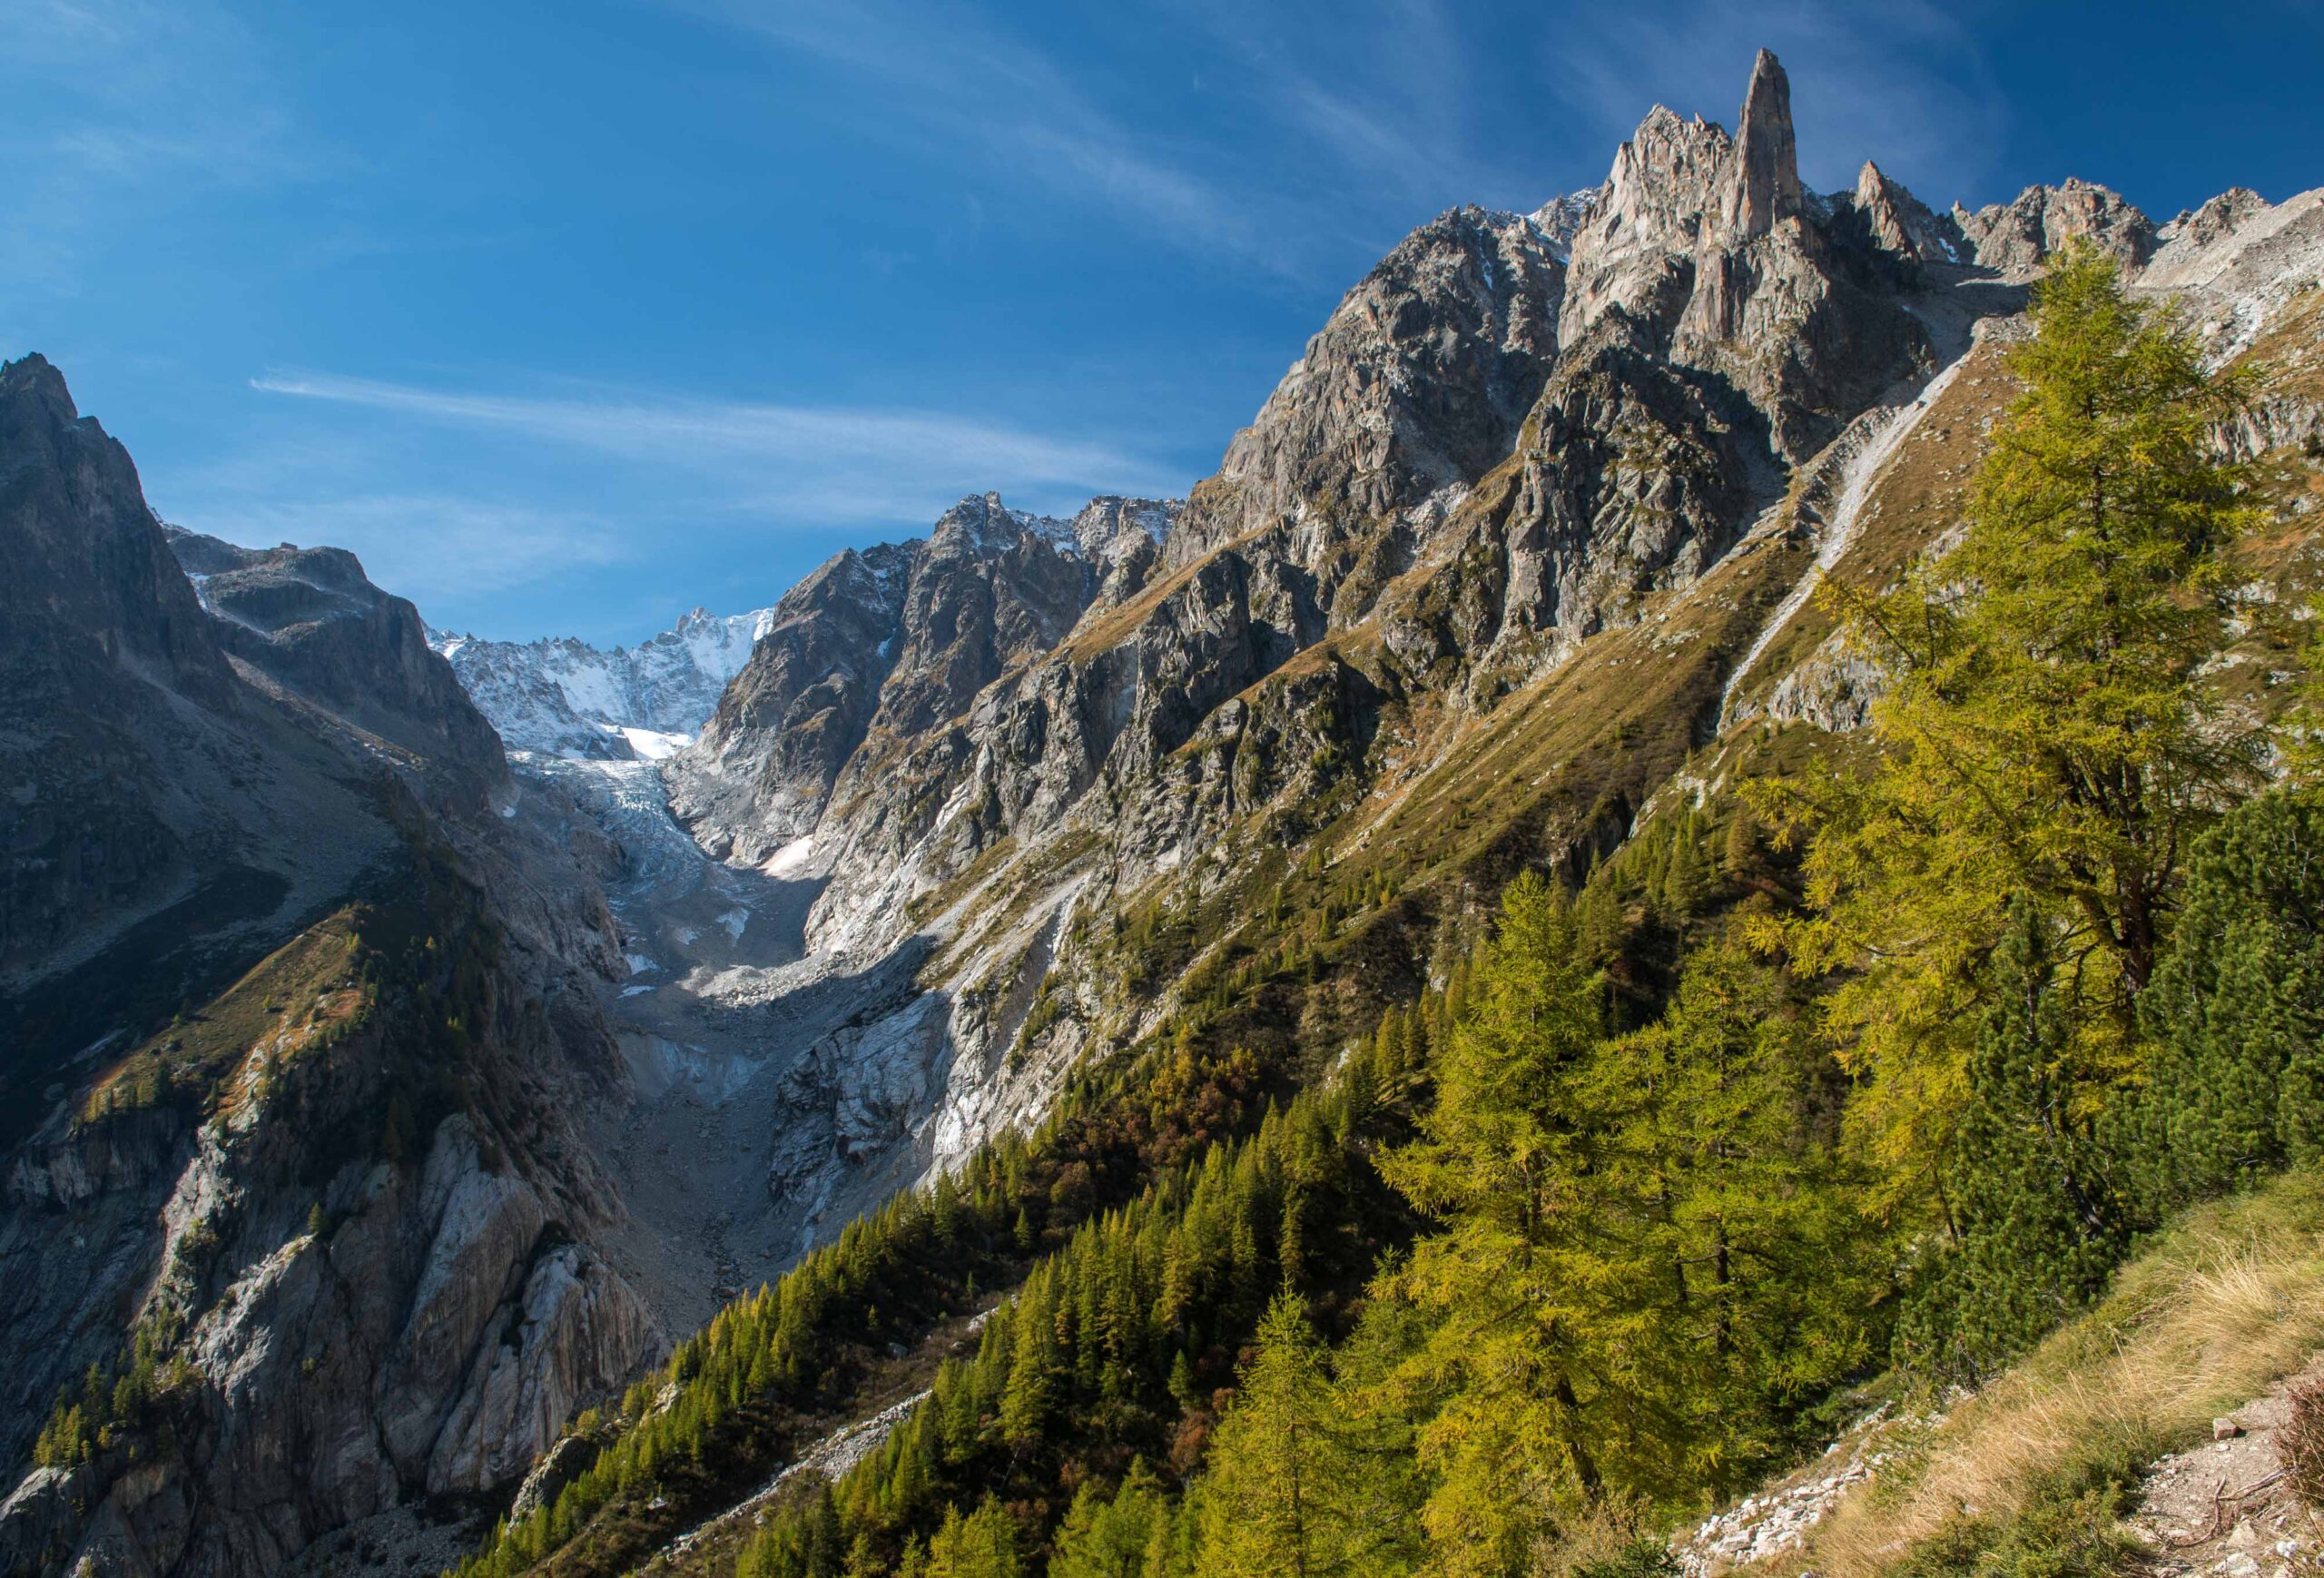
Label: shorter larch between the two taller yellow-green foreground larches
xmin=1576 ymin=937 xmax=1887 ymax=1504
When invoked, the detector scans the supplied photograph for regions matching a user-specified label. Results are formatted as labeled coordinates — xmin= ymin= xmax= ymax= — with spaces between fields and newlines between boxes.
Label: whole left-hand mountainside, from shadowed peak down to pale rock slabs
xmin=0 ymin=358 xmax=667 ymax=1575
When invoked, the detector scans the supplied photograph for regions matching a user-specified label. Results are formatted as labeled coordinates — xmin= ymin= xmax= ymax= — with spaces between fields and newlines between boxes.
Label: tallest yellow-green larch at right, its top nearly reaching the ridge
xmin=1752 ymin=246 xmax=2266 ymax=1185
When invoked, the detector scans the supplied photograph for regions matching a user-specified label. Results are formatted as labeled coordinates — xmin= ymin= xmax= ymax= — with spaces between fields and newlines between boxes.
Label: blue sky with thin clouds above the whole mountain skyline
xmin=0 ymin=0 xmax=2324 ymax=641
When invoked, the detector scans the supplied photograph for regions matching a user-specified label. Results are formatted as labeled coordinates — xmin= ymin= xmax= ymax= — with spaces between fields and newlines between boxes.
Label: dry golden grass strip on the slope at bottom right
xmin=1785 ymin=1171 xmax=2324 ymax=1578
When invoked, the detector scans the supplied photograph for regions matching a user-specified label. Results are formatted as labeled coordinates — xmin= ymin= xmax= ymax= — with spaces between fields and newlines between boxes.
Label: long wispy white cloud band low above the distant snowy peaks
xmin=146 ymin=370 xmax=1192 ymax=639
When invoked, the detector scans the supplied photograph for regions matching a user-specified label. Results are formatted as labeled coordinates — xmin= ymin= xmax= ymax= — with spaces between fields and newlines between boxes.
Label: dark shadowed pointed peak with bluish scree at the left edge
xmin=0 ymin=356 xmax=395 ymax=1110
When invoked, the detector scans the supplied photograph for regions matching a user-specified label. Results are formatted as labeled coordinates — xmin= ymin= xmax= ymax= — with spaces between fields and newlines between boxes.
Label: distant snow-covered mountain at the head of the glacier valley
xmin=428 ymin=609 xmax=773 ymax=760
